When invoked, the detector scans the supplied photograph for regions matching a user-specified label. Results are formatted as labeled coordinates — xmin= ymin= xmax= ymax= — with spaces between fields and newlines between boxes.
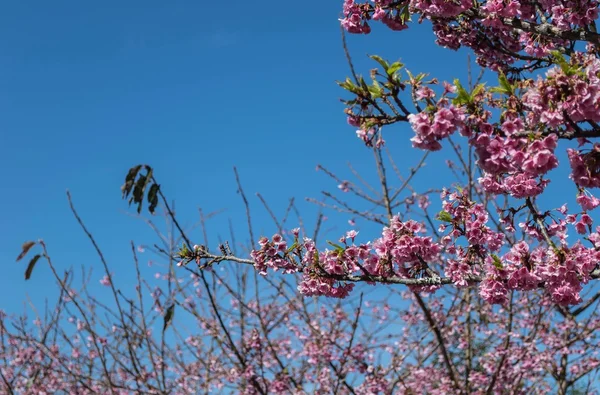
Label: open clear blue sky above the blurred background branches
xmin=0 ymin=0 xmax=506 ymax=311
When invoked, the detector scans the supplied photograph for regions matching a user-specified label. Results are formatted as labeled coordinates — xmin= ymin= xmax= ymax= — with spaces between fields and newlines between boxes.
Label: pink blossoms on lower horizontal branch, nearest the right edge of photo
xmin=440 ymin=187 xmax=600 ymax=305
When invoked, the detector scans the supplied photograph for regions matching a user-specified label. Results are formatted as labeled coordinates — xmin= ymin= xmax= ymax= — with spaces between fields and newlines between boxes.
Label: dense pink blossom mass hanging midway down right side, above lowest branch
xmin=400 ymin=54 xmax=600 ymax=206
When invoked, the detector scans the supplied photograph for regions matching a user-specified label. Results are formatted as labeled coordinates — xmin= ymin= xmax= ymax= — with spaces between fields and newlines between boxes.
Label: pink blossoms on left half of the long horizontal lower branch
xmin=251 ymin=220 xmax=441 ymax=298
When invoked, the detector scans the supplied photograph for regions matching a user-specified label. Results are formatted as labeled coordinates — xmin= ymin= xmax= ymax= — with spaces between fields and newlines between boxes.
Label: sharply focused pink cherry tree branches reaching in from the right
xmin=173 ymin=0 xmax=600 ymax=306
